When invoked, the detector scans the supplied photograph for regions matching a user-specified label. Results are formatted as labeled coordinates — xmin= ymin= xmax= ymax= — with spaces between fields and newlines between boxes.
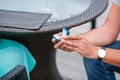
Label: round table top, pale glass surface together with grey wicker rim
xmin=0 ymin=0 xmax=108 ymax=33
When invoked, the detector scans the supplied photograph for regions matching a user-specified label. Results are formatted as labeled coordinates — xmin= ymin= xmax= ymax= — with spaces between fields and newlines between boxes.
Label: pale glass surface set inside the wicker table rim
xmin=0 ymin=0 xmax=91 ymax=21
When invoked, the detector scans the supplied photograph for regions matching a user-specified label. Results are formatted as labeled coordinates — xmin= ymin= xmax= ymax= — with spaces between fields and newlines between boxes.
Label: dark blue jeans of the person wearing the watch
xmin=84 ymin=41 xmax=120 ymax=80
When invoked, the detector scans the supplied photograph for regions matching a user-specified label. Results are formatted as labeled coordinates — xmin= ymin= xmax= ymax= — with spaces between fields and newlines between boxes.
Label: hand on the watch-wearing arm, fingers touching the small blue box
xmin=61 ymin=35 xmax=99 ymax=59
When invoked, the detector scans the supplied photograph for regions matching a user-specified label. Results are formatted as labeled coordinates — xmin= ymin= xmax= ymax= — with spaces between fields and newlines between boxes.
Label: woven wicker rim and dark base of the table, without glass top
xmin=0 ymin=0 xmax=108 ymax=80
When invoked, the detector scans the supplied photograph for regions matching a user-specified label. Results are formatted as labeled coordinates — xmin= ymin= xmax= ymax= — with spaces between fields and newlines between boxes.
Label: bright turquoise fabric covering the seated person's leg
xmin=0 ymin=39 xmax=36 ymax=77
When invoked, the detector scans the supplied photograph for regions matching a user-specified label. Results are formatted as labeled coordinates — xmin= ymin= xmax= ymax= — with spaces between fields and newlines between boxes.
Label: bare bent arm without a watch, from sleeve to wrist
xmin=82 ymin=3 xmax=120 ymax=46
